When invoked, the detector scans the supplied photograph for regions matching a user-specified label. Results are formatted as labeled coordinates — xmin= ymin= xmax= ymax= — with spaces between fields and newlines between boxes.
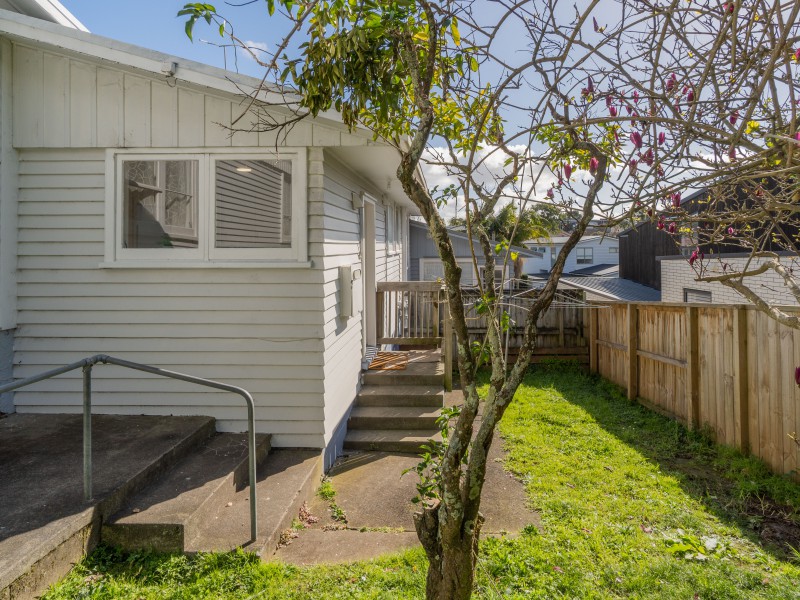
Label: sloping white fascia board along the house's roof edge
xmin=0 ymin=10 xmax=332 ymax=115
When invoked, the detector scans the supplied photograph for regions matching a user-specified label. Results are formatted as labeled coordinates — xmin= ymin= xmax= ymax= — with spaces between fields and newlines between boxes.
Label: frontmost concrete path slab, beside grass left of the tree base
xmin=273 ymin=529 xmax=419 ymax=565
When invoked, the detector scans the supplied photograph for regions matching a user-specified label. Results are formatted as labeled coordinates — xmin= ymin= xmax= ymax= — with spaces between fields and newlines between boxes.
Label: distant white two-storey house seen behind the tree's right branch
xmin=524 ymin=233 xmax=619 ymax=275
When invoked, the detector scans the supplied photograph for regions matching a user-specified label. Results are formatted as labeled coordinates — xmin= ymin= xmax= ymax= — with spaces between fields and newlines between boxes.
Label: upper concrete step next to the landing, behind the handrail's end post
xmin=101 ymin=433 xmax=270 ymax=552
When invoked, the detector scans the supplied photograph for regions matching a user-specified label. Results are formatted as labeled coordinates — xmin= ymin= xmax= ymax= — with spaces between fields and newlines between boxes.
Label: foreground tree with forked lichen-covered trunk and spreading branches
xmin=181 ymin=0 xmax=798 ymax=599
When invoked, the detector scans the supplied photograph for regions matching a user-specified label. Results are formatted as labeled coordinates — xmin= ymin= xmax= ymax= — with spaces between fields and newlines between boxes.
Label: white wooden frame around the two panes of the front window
xmin=103 ymin=148 xmax=308 ymax=267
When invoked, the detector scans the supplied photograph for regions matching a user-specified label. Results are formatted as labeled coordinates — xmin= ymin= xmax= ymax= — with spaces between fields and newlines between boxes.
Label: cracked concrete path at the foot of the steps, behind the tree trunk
xmin=265 ymin=392 xmax=540 ymax=565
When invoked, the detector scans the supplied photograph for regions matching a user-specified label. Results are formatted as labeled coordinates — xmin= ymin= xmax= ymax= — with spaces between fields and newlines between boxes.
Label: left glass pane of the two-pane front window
xmin=122 ymin=160 xmax=198 ymax=248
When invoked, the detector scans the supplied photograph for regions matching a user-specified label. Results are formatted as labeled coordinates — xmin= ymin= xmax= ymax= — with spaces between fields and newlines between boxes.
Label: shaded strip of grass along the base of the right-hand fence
xmin=525 ymin=364 xmax=800 ymax=559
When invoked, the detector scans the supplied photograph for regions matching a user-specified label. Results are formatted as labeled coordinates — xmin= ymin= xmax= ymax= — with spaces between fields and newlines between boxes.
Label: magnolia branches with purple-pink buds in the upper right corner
xmin=529 ymin=0 xmax=800 ymax=328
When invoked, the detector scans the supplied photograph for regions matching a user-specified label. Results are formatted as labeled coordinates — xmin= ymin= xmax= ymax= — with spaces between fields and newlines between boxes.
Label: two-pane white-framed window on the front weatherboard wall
xmin=106 ymin=151 xmax=307 ymax=264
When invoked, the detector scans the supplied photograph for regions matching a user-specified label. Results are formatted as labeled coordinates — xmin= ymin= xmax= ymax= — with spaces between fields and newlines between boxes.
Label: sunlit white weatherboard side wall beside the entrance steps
xmin=320 ymin=150 xmax=404 ymax=468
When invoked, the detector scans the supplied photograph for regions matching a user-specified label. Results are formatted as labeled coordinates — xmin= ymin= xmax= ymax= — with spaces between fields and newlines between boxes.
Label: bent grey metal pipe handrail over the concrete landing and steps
xmin=0 ymin=354 xmax=258 ymax=542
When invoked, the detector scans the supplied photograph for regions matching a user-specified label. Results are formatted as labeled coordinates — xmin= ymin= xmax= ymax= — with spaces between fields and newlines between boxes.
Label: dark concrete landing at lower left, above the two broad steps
xmin=0 ymin=414 xmax=214 ymax=598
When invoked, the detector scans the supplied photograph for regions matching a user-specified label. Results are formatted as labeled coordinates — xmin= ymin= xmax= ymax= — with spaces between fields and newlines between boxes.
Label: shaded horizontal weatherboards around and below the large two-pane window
xmin=14 ymin=149 xmax=325 ymax=448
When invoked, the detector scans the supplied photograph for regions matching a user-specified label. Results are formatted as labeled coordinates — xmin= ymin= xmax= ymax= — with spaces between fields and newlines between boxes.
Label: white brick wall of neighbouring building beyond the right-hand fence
xmin=661 ymin=257 xmax=797 ymax=306
